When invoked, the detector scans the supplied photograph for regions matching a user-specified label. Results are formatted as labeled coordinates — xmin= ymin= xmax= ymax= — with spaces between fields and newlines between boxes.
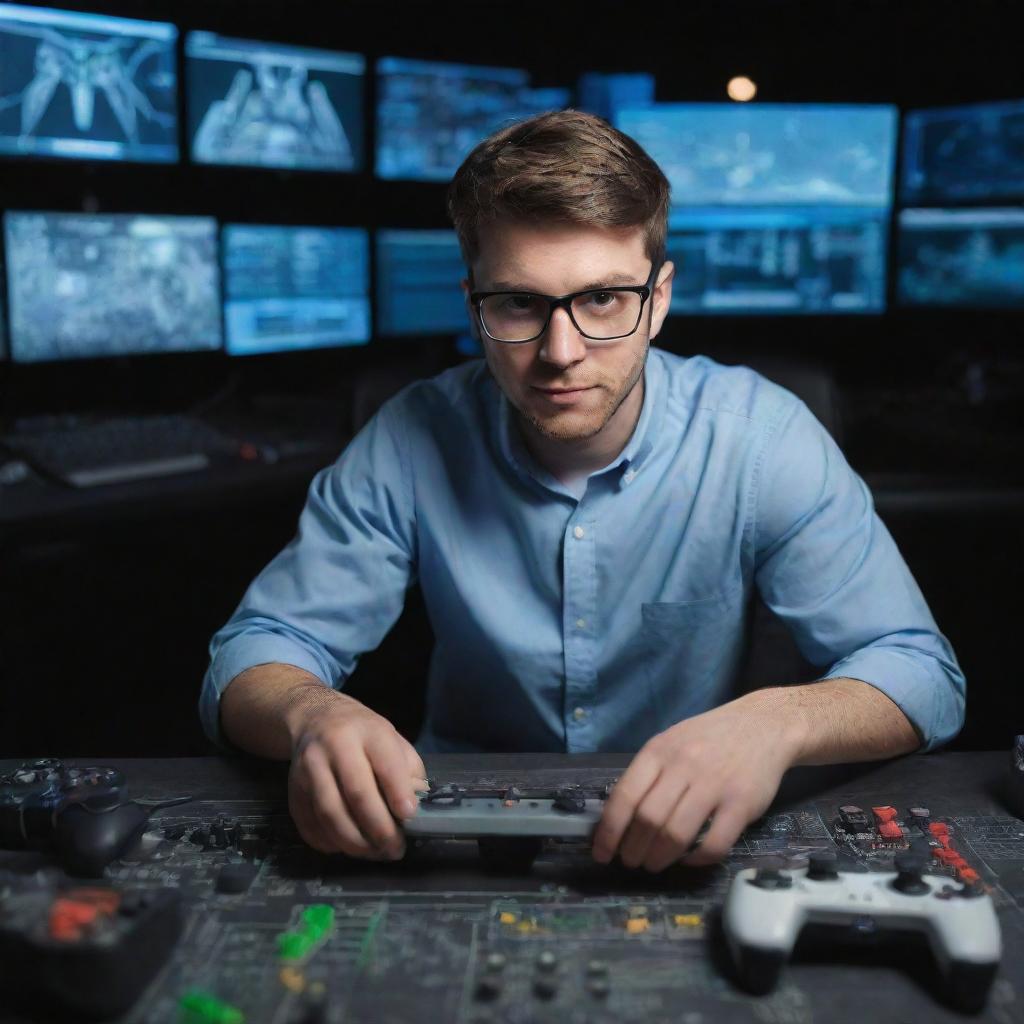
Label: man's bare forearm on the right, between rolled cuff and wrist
xmin=739 ymin=679 xmax=921 ymax=765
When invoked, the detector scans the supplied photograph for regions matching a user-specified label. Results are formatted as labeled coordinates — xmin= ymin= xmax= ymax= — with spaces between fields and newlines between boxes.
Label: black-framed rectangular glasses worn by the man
xmin=469 ymin=263 xmax=658 ymax=345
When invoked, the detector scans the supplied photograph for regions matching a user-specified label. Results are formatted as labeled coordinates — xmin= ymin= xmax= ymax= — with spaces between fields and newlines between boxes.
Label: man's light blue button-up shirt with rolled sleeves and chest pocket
xmin=200 ymin=349 xmax=965 ymax=752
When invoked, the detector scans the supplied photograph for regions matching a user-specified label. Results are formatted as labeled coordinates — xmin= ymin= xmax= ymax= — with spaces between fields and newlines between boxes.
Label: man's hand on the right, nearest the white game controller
xmin=593 ymin=691 xmax=803 ymax=871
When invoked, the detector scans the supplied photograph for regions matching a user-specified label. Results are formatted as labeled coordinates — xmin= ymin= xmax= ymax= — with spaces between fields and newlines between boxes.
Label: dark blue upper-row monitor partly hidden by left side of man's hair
xmin=377 ymin=57 xmax=569 ymax=181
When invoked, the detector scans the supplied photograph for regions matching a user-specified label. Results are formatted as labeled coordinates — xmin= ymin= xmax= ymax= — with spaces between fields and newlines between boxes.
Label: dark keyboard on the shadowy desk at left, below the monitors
xmin=2 ymin=414 xmax=239 ymax=487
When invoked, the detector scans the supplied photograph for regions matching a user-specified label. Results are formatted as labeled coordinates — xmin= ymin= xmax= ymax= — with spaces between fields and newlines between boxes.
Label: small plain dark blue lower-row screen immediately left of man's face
xmin=377 ymin=230 xmax=467 ymax=335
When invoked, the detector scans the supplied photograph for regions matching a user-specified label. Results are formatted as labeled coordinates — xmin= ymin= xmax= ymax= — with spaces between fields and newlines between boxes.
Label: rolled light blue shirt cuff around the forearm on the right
xmin=820 ymin=647 xmax=965 ymax=752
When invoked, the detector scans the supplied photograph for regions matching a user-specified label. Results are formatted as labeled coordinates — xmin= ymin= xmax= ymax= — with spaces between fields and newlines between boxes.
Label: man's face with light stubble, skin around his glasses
xmin=463 ymin=221 xmax=672 ymax=442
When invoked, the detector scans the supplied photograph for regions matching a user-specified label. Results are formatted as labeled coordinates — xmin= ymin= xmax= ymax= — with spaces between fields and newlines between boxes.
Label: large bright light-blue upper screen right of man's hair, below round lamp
xmin=615 ymin=103 xmax=896 ymax=208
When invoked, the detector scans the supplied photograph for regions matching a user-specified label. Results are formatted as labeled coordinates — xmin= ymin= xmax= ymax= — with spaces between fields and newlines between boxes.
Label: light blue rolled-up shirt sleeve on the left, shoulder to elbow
xmin=199 ymin=399 xmax=416 ymax=749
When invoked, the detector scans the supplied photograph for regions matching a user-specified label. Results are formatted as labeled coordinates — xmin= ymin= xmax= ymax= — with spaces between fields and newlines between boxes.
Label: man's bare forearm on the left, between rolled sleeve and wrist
xmin=220 ymin=664 xmax=354 ymax=761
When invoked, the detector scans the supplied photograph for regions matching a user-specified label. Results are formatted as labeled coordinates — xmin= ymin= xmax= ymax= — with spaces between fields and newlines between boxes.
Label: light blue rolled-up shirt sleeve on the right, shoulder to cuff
xmin=753 ymin=401 xmax=966 ymax=750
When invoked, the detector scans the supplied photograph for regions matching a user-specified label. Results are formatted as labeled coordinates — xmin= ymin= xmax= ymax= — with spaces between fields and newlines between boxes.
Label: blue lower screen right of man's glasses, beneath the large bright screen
xmin=668 ymin=207 xmax=888 ymax=313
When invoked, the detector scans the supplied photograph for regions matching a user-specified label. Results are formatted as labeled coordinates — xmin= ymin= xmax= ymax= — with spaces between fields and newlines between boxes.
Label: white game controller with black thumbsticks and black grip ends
xmin=723 ymin=850 xmax=1001 ymax=1012
